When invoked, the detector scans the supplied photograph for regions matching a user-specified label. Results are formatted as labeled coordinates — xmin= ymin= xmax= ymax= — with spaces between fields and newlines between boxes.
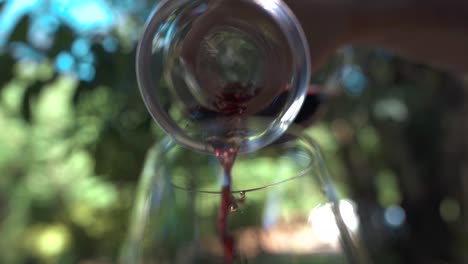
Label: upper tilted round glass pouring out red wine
xmin=136 ymin=0 xmax=311 ymax=153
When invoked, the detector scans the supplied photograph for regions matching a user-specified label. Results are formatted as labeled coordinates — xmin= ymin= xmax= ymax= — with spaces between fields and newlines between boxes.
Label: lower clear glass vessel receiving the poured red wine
xmin=120 ymin=128 xmax=367 ymax=264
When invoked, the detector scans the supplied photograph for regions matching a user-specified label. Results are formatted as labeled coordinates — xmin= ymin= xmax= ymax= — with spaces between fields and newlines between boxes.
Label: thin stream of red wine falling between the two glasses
xmin=216 ymin=148 xmax=238 ymax=264
